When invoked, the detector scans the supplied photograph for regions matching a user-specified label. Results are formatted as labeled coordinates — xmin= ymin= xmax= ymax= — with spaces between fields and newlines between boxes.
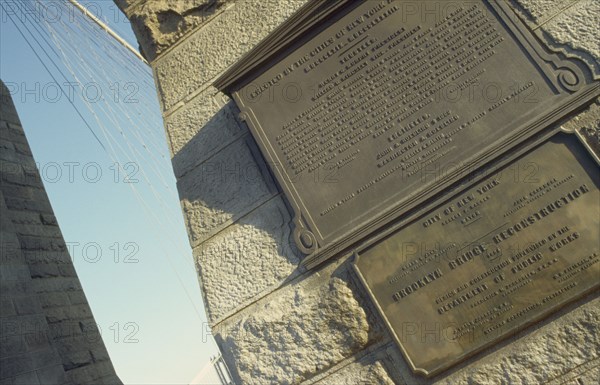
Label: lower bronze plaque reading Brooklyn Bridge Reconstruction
xmin=355 ymin=134 xmax=600 ymax=376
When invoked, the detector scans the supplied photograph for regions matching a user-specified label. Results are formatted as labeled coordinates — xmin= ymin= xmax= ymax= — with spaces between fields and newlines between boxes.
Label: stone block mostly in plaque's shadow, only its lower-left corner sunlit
xmin=177 ymin=138 xmax=275 ymax=246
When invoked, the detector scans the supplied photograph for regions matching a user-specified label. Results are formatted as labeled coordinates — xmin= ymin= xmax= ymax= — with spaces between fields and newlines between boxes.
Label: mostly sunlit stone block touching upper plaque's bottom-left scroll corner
xmin=194 ymin=197 xmax=299 ymax=323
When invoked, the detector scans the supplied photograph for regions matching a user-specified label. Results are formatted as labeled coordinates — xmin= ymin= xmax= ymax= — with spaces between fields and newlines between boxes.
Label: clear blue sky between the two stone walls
xmin=0 ymin=0 xmax=217 ymax=384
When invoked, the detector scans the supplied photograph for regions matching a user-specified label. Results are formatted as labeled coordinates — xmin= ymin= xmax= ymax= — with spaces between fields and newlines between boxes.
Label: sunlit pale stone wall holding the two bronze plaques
xmin=117 ymin=0 xmax=600 ymax=385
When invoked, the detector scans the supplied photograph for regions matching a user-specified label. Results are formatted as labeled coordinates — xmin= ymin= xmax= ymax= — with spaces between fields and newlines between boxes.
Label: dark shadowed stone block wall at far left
xmin=0 ymin=82 xmax=121 ymax=385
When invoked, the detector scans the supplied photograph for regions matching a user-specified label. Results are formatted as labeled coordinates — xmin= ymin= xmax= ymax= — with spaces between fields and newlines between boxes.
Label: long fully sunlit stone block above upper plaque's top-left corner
xmin=153 ymin=0 xmax=304 ymax=111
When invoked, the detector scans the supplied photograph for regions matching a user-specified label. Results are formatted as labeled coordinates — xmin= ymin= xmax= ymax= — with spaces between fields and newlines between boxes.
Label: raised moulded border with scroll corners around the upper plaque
xmin=217 ymin=0 xmax=600 ymax=268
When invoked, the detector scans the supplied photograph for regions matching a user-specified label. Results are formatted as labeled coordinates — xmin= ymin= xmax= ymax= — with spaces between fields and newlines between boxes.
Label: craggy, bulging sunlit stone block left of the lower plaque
xmin=216 ymin=276 xmax=369 ymax=385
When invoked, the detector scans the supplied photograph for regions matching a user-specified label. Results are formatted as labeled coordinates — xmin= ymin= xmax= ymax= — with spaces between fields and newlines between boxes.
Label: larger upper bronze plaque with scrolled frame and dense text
xmin=216 ymin=0 xmax=600 ymax=267
